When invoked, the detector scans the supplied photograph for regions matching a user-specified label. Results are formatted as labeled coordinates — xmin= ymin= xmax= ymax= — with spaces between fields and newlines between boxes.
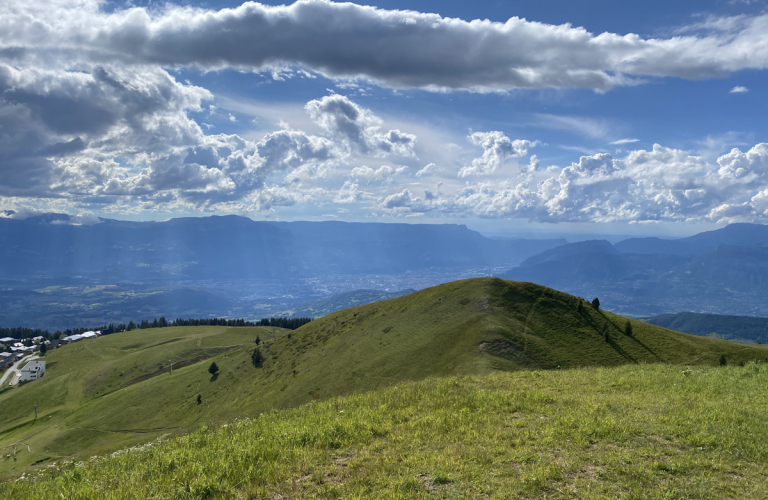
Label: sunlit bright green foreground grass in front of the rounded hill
xmin=0 ymin=364 xmax=768 ymax=499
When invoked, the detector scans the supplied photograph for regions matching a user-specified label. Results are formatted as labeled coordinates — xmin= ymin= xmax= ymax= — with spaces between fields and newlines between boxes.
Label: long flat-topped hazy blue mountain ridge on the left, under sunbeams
xmin=0 ymin=214 xmax=566 ymax=282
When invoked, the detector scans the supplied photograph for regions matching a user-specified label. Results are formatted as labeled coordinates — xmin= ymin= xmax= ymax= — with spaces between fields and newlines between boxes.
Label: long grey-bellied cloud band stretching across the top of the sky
xmin=0 ymin=0 xmax=768 ymax=91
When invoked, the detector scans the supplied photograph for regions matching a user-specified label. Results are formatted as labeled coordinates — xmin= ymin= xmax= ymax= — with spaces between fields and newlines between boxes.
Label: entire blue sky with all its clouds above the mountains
xmin=0 ymin=0 xmax=768 ymax=236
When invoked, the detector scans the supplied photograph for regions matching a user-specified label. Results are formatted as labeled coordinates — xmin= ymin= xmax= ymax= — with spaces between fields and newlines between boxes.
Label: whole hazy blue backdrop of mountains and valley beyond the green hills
xmin=0 ymin=214 xmax=768 ymax=328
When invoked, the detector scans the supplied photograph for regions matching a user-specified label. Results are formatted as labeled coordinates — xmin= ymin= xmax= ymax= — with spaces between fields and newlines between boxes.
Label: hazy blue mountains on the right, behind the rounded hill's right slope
xmin=501 ymin=224 xmax=768 ymax=316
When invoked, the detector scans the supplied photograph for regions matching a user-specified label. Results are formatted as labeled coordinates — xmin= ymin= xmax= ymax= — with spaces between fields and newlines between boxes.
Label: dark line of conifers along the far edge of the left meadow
xmin=0 ymin=316 xmax=312 ymax=340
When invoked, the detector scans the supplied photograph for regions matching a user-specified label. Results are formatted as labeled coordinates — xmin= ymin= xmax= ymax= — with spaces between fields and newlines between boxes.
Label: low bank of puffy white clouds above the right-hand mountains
xmin=382 ymin=143 xmax=768 ymax=222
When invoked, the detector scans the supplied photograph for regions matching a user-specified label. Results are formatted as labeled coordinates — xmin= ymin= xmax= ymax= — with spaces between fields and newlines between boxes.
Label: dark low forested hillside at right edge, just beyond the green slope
xmin=644 ymin=312 xmax=768 ymax=344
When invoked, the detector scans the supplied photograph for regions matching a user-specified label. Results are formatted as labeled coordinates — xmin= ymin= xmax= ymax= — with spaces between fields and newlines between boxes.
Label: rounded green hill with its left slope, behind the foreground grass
xmin=0 ymin=278 xmax=768 ymax=474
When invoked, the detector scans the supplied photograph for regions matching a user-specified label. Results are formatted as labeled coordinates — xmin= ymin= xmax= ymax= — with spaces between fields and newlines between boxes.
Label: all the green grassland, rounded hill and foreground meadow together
xmin=0 ymin=278 xmax=768 ymax=498
